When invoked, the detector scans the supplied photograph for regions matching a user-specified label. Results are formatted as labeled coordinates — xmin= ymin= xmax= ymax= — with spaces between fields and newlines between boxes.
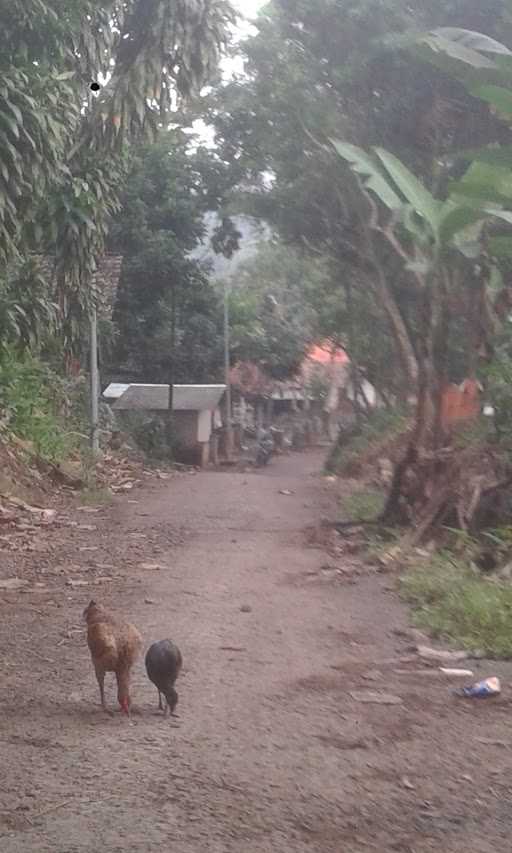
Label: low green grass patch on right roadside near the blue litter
xmin=401 ymin=553 xmax=512 ymax=658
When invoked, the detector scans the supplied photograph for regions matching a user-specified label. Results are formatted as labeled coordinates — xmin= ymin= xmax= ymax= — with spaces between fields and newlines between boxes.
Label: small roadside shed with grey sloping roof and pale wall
xmin=112 ymin=384 xmax=226 ymax=467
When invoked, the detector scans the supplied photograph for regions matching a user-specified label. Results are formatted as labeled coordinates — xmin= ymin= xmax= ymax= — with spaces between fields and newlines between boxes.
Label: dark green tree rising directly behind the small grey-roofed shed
xmin=108 ymin=129 xmax=228 ymax=383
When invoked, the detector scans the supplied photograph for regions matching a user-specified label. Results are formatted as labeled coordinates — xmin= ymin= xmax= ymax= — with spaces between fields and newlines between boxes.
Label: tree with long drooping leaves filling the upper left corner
xmin=0 ymin=0 xmax=232 ymax=356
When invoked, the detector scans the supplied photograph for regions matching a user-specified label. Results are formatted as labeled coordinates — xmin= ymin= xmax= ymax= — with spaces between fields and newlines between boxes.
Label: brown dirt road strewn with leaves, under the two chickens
xmin=0 ymin=454 xmax=512 ymax=853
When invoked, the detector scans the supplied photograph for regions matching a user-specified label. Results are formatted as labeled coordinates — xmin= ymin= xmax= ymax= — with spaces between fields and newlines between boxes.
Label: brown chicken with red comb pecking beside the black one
xmin=84 ymin=601 xmax=142 ymax=716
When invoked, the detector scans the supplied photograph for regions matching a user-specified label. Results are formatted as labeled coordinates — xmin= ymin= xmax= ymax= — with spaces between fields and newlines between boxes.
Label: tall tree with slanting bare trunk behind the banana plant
xmin=206 ymin=0 xmax=510 ymax=393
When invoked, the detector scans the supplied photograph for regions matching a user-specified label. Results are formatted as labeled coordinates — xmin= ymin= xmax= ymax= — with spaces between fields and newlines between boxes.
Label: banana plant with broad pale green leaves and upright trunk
xmin=331 ymin=140 xmax=512 ymax=517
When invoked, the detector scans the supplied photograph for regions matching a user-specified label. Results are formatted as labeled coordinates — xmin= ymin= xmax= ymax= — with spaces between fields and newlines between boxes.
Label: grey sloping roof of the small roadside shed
xmin=112 ymin=384 xmax=226 ymax=412
